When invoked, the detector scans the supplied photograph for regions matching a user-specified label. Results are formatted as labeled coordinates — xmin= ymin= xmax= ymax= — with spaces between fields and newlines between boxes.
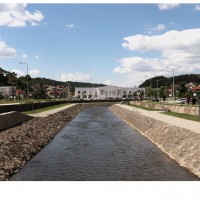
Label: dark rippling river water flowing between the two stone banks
xmin=10 ymin=107 xmax=199 ymax=181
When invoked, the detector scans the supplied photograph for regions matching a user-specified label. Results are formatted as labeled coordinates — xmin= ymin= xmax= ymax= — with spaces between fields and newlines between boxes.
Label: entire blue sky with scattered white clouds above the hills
xmin=0 ymin=3 xmax=200 ymax=87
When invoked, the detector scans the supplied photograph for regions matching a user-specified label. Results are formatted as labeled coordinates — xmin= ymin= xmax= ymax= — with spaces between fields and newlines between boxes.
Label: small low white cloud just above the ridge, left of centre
xmin=61 ymin=72 xmax=90 ymax=82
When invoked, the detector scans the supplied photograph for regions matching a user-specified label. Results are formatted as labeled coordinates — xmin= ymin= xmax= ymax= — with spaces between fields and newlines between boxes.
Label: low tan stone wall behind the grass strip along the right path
xmin=131 ymin=101 xmax=199 ymax=115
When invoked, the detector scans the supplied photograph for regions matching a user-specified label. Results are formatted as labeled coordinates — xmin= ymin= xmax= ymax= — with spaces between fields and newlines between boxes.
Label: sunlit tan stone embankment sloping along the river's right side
xmin=110 ymin=105 xmax=200 ymax=177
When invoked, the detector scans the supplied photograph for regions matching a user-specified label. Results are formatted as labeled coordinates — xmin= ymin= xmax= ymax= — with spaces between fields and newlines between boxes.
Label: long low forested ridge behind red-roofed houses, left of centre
xmin=31 ymin=77 xmax=105 ymax=91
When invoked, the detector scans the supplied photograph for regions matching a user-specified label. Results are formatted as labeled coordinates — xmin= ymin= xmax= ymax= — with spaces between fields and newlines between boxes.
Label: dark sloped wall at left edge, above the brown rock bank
xmin=0 ymin=111 xmax=33 ymax=131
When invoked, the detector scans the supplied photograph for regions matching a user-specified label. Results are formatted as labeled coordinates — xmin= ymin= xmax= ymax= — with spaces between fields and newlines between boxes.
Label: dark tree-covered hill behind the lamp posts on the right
xmin=139 ymin=74 xmax=200 ymax=88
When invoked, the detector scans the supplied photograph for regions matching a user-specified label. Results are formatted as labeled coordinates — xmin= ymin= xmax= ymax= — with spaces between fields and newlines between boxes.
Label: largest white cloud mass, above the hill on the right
xmin=113 ymin=29 xmax=200 ymax=83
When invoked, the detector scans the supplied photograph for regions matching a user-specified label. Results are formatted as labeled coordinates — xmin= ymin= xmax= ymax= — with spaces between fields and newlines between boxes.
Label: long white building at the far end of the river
xmin=75 ymin=86 xmax=145 ymax=100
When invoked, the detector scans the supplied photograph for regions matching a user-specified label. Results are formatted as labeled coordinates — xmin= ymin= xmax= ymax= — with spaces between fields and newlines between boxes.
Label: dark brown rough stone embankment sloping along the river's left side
xmin=0 ymin=103 xmax=111 ymax=180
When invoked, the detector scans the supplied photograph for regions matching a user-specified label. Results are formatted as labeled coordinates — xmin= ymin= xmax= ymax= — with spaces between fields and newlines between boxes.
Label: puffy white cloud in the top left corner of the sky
xmin=0 ymin=3 xmax=44 ymax=27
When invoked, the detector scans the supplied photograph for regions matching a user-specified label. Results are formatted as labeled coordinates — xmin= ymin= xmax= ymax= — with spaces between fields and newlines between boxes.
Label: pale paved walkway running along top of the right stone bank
xmin=117 ymin=104 xmax=200 ymax=133
